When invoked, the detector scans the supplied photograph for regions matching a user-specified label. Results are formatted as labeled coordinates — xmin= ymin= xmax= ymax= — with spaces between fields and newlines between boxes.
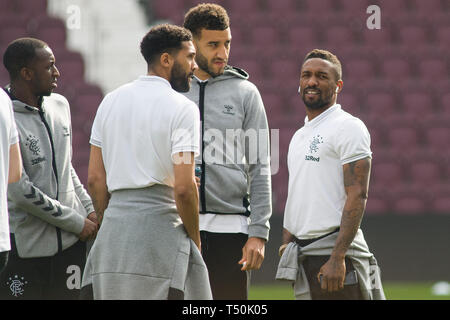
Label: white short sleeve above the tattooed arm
xmin=336 ymin=118 xmax=372 ymax=165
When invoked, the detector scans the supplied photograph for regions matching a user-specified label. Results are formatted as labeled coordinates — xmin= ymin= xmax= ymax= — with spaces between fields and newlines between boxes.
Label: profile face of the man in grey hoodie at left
xmin=29 ymin=47 xmax=60 ymax=96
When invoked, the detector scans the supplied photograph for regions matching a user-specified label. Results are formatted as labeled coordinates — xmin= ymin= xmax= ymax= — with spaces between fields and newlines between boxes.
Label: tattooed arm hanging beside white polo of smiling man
xmin=317 ymin=158 xmax=371 ymax=292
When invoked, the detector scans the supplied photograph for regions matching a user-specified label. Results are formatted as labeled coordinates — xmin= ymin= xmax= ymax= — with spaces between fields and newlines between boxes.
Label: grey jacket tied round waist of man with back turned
xmin=82 ymin=185 xmax=212 ymax=300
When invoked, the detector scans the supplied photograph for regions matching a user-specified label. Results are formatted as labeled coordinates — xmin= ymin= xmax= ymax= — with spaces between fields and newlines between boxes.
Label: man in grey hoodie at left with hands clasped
xmin=0 ymin=38 xmax=97 ymax=299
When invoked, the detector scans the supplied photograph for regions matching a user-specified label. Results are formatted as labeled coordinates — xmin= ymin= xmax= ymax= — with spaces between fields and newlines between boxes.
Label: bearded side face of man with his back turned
xmin=169 ymin=41 xmax=197 ymax=92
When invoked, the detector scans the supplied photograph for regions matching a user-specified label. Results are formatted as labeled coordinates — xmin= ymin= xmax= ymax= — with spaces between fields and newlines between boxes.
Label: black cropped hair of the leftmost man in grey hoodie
xmin=3 ymin=38 xmax=48 ymax=80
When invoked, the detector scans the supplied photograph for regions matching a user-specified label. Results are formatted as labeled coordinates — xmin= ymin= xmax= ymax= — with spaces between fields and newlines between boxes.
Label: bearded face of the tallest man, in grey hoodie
xmin=194 ymin=28 xmax=231 ymax=77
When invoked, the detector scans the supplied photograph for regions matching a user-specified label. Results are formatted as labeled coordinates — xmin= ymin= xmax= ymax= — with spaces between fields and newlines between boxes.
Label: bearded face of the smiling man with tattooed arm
xmin=300 ymin=58 xmax=342 ymax=109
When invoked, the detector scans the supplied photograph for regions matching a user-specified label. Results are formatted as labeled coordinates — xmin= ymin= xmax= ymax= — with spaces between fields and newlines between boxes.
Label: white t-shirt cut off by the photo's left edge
xmin=0 ymin=88 xmax=19 ymax=252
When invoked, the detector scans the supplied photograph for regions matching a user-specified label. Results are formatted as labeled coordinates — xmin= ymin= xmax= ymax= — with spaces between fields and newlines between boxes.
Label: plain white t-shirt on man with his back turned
xmin=90 ymin=76 xmax=200 ymax=192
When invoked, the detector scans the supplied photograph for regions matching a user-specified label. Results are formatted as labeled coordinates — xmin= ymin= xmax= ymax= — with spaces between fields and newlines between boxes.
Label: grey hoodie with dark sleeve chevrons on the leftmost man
xmin=8 ymin=93 xmax=94 ymax=258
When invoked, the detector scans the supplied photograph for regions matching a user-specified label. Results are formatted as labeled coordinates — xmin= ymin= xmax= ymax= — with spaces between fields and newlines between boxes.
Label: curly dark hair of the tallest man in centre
xmin=184 ymin=3 xmax=230 ymax=37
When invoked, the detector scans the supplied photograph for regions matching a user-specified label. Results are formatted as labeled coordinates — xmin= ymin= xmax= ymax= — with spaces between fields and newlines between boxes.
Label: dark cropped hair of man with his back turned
xmin=140 ymin=24 xmax=192 ymax=65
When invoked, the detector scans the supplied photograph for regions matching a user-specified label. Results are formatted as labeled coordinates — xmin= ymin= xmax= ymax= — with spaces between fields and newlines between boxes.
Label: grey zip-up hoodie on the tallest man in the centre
xmin=185 ymin=66 xmax=272 ymax=240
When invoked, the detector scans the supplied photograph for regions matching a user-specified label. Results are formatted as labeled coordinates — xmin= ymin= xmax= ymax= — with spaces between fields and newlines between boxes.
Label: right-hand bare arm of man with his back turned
xmin=173 ymin=152 xmax=201 ymax=249
